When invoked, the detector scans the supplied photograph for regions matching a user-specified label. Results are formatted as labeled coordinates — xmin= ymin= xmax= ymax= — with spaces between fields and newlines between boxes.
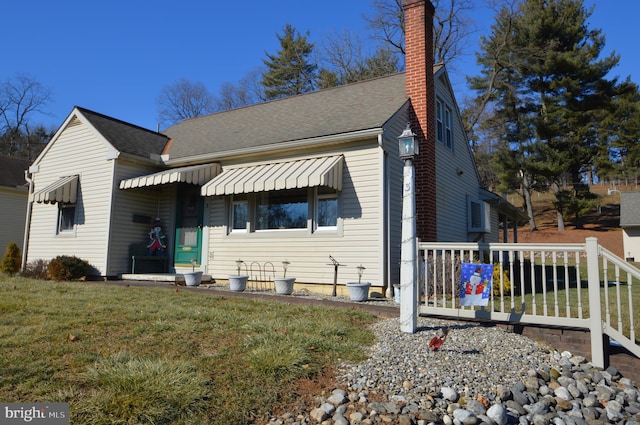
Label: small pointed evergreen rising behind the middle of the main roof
xmin=262 ymin=24 xmax=318 ymax=99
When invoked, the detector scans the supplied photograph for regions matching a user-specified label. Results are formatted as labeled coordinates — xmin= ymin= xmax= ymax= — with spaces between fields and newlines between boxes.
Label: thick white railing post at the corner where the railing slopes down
xmin=586 ymin=238 xmax=607 ymax=368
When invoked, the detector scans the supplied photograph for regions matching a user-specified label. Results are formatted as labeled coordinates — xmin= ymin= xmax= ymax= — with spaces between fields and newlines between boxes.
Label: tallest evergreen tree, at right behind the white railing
xmin=470 ymin=0 xmax=620 ymax=230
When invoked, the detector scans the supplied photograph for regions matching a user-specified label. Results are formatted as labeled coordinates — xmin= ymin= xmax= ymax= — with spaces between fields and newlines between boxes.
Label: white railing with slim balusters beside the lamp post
xmin=418 ymin=238 xmax=640 ymax=366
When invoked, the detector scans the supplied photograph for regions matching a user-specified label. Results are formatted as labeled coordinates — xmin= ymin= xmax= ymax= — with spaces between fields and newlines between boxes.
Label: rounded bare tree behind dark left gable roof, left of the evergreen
xmin=158 ymin=78 xmax=215 ymax=126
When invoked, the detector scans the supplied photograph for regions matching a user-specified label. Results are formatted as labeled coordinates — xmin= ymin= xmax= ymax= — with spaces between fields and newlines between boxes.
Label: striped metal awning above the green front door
xmin=120 ymin=163 xmax=220 ymax=189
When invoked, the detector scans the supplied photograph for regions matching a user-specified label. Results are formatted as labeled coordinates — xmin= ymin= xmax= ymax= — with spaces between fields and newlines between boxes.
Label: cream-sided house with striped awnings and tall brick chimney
xmin=25 ymin=0 xmax=520 ymax=288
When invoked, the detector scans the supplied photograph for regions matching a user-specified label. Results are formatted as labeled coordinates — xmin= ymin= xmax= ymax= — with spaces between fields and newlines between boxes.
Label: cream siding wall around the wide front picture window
xmin=205 ymin=139 xmax=384 ymax=286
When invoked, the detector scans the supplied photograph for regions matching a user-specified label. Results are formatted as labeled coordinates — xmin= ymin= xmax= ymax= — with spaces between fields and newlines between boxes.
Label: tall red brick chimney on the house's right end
xmin=403 ymin=0 xmax=437 ymax=241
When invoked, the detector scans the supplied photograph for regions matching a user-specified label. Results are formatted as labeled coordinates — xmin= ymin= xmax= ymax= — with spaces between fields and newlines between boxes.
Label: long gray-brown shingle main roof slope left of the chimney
xmin=163 ymin=73 xmax=407 ymax=160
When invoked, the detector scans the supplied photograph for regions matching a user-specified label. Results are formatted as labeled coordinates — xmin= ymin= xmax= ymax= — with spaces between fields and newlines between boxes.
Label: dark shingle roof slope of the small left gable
xmin=77 ymin=107 xmax=169 ymax=158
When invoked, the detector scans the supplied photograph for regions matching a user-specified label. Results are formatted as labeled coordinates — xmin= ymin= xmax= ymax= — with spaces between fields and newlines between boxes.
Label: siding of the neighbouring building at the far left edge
xmin=0 ymin=187 xmax=28 ymax=252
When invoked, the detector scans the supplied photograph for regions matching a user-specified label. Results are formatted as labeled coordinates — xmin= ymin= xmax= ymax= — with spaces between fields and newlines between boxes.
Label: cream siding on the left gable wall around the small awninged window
xmin=27 ymin=117 xmax=113 ymax=274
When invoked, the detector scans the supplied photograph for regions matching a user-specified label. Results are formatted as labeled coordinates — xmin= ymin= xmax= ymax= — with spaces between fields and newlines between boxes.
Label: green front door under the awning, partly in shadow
xmin=174 ymin=184 xmax=204 ymax=267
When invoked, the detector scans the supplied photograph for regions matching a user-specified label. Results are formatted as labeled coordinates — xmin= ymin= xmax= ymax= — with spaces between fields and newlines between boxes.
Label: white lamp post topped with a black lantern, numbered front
xmin=398 ymin=124 xmax=418 ymax=333
